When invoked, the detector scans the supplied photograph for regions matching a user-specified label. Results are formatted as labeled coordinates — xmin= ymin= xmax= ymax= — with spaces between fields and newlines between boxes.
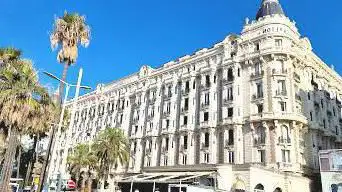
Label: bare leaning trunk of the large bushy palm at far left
xmin=0 ymin=128 xmax=18 ymax=192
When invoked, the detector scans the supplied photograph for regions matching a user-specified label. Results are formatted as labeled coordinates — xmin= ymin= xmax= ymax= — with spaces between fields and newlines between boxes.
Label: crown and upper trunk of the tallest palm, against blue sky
xmin=50 ymin=12 xmax=90 ymax=97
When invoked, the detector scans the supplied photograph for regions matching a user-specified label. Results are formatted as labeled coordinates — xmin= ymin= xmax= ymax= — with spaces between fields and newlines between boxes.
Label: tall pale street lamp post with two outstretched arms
xmin=41 ymin=68 xmax=91 ymax=192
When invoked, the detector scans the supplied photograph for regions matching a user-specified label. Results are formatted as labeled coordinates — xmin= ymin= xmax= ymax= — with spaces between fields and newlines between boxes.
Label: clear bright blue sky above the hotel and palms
xmin=0 ymin=0 xmax=342 ymax=97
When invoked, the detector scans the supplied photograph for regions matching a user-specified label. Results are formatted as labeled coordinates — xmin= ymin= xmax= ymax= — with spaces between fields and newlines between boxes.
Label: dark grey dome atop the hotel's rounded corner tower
xmin=256 ymin=0 xmax=285 ymax=20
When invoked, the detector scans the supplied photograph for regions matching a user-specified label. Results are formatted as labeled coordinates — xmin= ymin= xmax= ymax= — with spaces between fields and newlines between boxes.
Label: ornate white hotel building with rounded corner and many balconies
xmin=52 ymin=0 xmax=342 ymax=192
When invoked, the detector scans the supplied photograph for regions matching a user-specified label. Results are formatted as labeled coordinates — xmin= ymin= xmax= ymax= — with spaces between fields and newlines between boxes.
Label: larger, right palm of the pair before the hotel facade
xmin=93 ymin=128 xmax=129 ymax=190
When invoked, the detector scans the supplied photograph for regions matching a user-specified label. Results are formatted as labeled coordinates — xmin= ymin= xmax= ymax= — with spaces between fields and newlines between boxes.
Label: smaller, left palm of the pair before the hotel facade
xmin=67 ymin=144 xmax=98 ymax=191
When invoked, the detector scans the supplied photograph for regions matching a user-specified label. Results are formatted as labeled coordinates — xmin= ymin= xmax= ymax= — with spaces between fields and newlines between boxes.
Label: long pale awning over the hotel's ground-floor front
xmin=119 ymin=171 xmax=216 ymax=183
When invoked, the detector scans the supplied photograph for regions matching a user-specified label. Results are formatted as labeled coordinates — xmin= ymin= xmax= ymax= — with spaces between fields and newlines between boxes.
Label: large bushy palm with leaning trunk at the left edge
xmin=0 ymin=57 xmax=56 ymax=191
